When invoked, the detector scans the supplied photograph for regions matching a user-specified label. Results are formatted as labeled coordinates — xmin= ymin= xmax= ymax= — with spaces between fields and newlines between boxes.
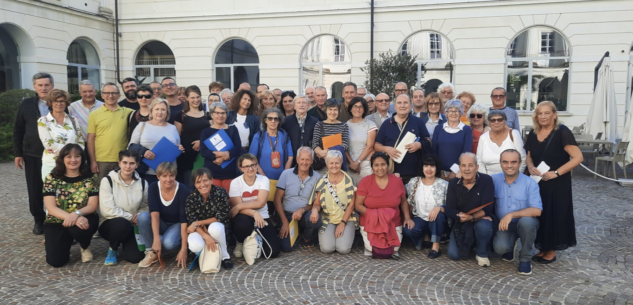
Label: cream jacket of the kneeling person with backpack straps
xmin=99 ymin=170 xmax=149 ymax=225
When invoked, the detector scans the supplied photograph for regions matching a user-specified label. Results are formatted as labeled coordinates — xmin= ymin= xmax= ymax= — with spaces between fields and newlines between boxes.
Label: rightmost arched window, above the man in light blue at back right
xmin=505 ymin=26 xmax=569 ymax=111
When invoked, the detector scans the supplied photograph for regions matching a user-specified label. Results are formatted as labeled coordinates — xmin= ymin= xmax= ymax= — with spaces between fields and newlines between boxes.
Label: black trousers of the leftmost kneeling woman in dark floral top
xmin=44 ymin=214 xmax=99 ymax=268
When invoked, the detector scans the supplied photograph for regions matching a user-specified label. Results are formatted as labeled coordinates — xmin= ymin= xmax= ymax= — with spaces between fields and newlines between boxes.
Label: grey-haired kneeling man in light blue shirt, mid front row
xmin=274 ymin=146 xmax=321 ymax=252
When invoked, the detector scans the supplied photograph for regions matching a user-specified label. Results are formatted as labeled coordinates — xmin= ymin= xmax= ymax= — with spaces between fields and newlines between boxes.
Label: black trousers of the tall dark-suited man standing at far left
xmin=23 ymin=156 xmax=46 ymax=223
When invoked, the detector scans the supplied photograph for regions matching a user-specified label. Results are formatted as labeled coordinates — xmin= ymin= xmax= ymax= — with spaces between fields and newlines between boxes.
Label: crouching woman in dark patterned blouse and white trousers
xmin=185 ymin=167 xmax=233 ymax=269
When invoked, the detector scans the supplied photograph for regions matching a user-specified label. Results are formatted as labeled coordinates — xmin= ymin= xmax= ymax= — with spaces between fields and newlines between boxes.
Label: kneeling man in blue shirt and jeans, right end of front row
xmin=492 ymin=149 xmax=543 ymax=275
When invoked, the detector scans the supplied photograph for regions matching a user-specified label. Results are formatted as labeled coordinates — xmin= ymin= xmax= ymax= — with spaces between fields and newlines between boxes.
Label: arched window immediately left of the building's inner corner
xmin=66 ymin=39 xmax=101 ymax=94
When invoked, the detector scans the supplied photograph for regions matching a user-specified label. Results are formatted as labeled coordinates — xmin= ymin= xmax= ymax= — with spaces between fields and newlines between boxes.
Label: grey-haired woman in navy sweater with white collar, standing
xmin=432 ymin=99 xmax=473 ymax=180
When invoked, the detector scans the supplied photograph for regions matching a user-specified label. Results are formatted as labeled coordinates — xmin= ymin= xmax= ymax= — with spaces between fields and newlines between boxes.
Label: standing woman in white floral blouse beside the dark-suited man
xmin=37 ymin=89 xmax=86 ymax=180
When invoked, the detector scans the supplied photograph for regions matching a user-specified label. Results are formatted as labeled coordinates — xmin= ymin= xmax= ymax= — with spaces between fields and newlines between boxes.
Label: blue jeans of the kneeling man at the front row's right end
xmin=492 ymin=217 xmax=539 ymax=262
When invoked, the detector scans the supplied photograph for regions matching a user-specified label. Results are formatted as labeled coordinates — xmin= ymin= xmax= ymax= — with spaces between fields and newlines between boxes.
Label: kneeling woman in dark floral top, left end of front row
xmin=43 ymin=144 xmax=99 ymax=267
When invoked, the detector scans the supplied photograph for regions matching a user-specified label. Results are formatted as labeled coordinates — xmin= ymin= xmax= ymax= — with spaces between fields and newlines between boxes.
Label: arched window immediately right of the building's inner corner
xmin=134 ymin=41 xmax=176 ymax=84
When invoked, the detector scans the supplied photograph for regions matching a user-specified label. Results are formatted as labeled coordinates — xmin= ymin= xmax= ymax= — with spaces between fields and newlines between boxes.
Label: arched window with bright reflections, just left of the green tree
xmin=299 ymin=35 xmax=352 ymax=99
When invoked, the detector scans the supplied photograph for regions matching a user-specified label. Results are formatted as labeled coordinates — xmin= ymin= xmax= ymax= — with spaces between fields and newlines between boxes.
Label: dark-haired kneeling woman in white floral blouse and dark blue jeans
xmin=402 ymin=156 xmax=448 ymax=258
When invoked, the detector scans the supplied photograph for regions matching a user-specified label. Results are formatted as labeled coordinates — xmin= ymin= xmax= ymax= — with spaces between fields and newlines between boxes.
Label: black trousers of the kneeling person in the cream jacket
xmin=99 ymin=217 xmax=145 ymax=264
